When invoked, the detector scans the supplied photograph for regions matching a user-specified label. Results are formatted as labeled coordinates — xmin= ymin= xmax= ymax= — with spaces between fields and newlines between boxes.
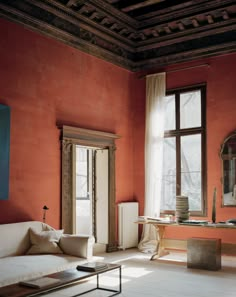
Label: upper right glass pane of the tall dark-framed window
xmin=180 ymin=90 xmax=201 ymax=129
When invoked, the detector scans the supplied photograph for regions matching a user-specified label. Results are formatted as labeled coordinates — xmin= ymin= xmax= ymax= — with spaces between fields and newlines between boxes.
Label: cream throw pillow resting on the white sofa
xmin=26 ymin=228 xmax=64 ymax=255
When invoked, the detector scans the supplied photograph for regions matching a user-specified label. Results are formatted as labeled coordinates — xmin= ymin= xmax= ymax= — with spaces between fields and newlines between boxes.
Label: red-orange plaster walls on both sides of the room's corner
xmin=0 ymin=20 xmax=236 ymax=243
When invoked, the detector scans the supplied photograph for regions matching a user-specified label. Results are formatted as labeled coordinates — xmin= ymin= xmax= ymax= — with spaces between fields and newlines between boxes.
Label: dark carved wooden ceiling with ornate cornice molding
xmin=0 ymin=0 xmax=236 ymax=71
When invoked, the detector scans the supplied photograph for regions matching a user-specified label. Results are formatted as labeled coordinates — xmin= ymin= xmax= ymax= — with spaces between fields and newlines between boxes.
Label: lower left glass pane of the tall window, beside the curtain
xmin=161 ymin=137 xmax=176 ymax=210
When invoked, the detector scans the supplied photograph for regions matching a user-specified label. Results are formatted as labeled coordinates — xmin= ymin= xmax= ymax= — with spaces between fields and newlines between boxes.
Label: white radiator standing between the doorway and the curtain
xmin=118 ymin=202 xmax=138 ymax=250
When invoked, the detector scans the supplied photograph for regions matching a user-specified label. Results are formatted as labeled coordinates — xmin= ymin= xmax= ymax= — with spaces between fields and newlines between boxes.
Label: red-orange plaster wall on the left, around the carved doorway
xmin=0 ymin=20 xmax=133 ymax=228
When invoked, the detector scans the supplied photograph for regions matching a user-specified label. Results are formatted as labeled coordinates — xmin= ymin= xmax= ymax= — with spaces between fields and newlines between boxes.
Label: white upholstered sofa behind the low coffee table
xmin=0 ymin=221 xmax=94 ymax=287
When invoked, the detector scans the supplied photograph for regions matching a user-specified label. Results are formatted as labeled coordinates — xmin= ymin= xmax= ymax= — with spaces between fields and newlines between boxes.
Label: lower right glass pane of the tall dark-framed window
xmin=181 ymin=134 xmax=202 ymax=211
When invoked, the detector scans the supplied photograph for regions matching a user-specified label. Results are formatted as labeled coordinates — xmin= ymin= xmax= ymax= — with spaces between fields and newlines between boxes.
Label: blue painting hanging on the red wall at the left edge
xmin=0 ymin=104 xmax=10 ymax=200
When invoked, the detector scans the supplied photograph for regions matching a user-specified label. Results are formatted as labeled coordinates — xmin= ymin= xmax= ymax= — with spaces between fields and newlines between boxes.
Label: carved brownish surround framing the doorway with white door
xmin=61 ymin=125 xmax=120 ymax=252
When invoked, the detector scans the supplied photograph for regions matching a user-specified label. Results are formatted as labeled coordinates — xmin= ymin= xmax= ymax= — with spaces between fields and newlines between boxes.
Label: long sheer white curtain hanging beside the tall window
xmin=138 ymin=73 xmax=166 ymax=253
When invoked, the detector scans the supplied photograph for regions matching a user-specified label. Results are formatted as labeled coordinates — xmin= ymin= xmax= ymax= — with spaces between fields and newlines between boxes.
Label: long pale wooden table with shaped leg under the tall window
xmin=135 ymin=220 xmax=236 ymax=260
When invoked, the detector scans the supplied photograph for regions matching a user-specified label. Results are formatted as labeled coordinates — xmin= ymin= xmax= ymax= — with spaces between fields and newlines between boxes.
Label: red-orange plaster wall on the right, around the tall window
xmin=134 ymin=54 xmax=236 ymax=243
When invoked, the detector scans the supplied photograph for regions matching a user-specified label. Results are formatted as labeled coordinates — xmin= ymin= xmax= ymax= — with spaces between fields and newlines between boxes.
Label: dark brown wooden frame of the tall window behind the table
xmin=161 ymin=84 xmax=207 ymax=216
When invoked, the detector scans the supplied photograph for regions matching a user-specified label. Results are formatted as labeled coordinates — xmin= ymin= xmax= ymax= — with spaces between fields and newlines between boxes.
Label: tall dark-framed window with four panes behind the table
xmin=161 ymin=86 xmax=206 ymax=215
